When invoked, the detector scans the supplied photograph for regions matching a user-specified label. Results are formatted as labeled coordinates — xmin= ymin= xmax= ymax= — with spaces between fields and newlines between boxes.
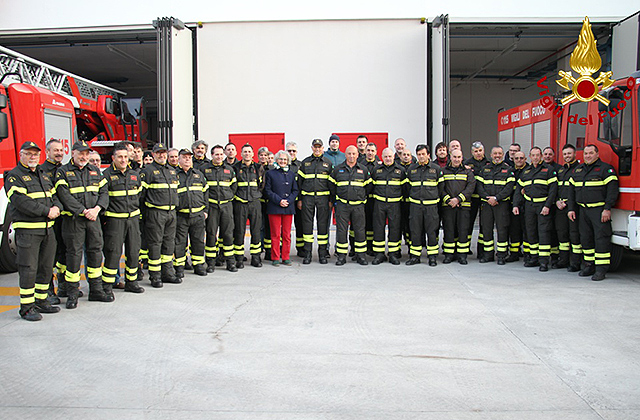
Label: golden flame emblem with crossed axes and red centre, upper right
xmin=556 ymin=16 xmax=615 ymax=105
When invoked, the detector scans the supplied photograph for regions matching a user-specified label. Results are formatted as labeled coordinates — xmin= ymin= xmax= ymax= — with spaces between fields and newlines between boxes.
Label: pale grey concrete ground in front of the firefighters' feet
xmin=0 ymin=231 xmax=640 ymax=420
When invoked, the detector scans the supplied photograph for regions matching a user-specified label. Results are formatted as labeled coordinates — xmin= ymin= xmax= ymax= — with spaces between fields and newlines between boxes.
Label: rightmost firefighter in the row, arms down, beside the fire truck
xmin=567 ymin=144 xmax=618 ymax=281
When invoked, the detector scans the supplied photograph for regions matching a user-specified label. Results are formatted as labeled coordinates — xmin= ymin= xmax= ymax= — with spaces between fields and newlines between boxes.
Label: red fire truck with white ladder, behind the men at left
xmin=0 ymin=47 xmax=148 ymax=272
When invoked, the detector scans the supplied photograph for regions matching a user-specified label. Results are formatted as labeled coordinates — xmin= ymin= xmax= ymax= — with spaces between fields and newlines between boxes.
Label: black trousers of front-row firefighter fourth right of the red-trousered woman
xmin=409 ymin=203 xmax=440 ymax=258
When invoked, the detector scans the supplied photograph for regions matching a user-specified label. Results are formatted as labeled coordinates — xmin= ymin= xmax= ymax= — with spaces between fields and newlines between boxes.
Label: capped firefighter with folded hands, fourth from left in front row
xmin=140 ymin=143 xmax=182 ymax=288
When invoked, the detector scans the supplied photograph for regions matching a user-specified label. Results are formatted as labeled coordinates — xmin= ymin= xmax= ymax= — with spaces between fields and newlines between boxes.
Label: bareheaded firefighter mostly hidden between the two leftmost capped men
xmin=39 ymin=139 xmax=67 ymax=305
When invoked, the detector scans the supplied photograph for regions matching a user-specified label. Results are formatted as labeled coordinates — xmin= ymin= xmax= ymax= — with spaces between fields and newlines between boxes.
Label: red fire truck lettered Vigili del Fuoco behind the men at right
xmin=498 ymin=72 xmax=640 ymax=269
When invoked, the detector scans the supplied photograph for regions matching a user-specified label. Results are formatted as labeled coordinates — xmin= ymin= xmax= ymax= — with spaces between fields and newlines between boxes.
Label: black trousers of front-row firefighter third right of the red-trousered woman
xmin=370 ymin=198 xmax=402 ymax=258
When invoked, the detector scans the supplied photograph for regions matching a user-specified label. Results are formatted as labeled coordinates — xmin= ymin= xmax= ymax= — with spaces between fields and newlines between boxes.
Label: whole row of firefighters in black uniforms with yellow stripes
xmin=5 ymin=135 xmax=618 ymax=321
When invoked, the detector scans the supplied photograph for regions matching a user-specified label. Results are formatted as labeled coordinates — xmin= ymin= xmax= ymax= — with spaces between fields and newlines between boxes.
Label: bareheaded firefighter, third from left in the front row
xmin=102 ymin=142 xmax=144 ymax=293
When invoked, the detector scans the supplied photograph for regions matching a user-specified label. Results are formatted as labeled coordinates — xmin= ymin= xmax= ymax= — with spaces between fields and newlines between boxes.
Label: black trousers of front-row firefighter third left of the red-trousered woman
xmin=173 ymin=210 xmax=205 ymax=267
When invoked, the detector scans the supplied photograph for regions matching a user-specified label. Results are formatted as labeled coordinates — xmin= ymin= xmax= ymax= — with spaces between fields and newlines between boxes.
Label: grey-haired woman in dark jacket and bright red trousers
xmin=264 ymin=150 xmax=298 ymax=266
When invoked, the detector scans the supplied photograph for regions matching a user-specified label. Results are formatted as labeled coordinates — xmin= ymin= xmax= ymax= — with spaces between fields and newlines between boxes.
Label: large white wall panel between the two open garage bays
xmin=198 ymin=19 xmax=427 ymax=156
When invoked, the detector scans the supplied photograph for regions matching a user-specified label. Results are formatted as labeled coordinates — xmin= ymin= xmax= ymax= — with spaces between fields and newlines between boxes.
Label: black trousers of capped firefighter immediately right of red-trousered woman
xmin=301 ymin=194 xmax=330 ymax=257
